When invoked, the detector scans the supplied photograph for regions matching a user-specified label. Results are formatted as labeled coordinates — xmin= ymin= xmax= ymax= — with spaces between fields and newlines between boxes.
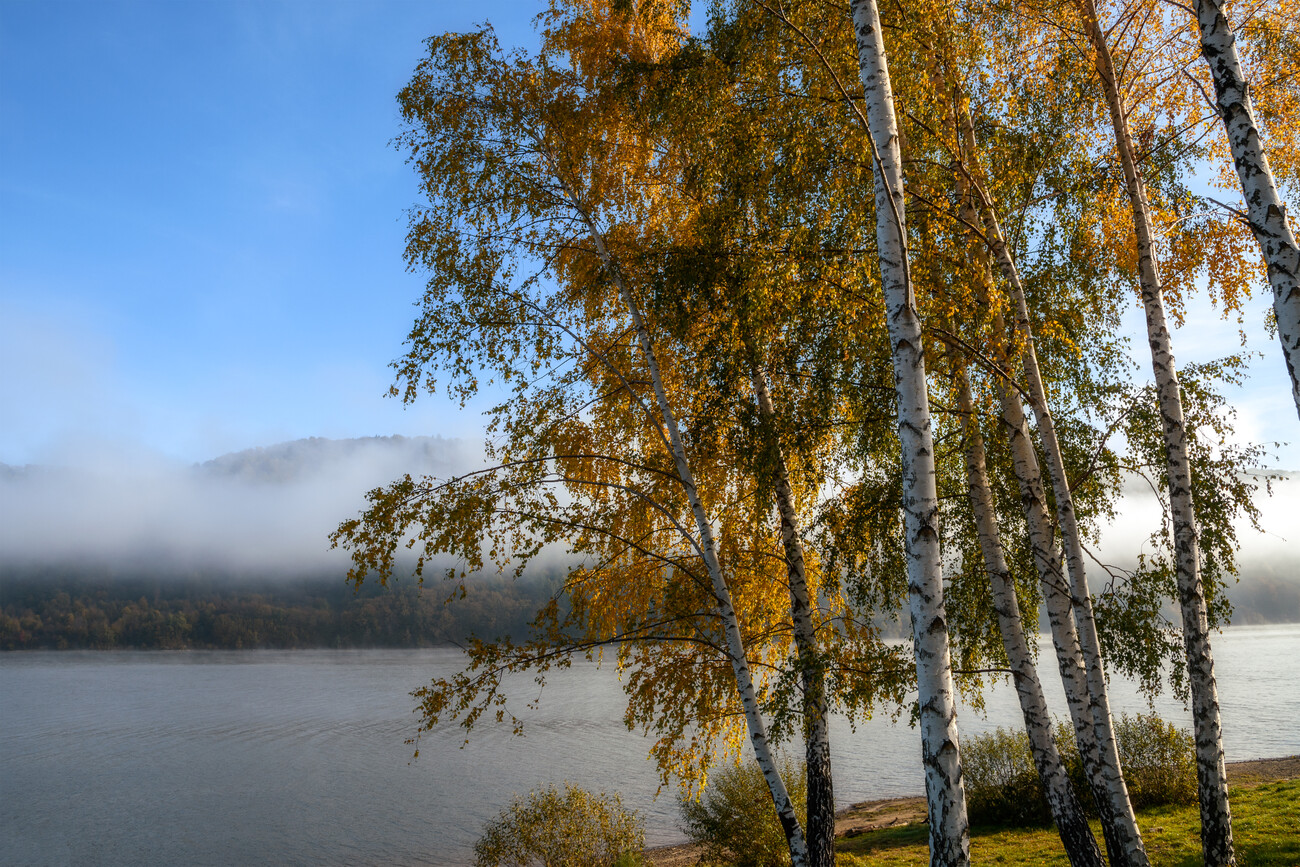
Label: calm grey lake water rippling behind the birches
xmin=0 ymin=625 xmax=1300 ymax=866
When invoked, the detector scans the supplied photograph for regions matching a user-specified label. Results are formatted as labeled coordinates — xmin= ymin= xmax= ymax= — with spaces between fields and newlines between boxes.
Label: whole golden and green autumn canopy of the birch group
xmin=334 ymin=0 xmax=1300 ymax=864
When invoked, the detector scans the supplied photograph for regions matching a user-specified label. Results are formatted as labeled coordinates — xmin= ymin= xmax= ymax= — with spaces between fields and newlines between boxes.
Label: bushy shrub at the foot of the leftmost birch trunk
xmin=681 ymin=759 xmax=807 ymax=867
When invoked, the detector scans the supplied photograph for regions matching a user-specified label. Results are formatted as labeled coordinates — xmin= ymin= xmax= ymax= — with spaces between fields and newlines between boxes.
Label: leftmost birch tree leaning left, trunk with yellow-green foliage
xmin=330 ymin=20 xmax=807 ymax=864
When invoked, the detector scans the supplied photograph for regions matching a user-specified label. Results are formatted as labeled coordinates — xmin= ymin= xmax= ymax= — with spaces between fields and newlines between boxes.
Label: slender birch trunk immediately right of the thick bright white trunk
xmin=956 ymin=364 xmax=1105 ymax=867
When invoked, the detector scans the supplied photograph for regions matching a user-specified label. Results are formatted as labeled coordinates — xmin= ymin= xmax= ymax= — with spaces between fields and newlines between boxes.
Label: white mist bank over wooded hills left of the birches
xmin=0 ymin=437 xmax=482 ymax=576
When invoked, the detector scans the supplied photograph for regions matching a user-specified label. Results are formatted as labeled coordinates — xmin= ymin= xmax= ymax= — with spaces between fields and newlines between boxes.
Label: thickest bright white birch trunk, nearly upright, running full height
xmin=850 ymin=0 xmax=970 ymax=866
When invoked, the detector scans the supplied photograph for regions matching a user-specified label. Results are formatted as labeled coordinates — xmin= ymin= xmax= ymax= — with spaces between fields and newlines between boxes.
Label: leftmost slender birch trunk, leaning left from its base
xmin=575 ymin=218 xmax=809 ymax=867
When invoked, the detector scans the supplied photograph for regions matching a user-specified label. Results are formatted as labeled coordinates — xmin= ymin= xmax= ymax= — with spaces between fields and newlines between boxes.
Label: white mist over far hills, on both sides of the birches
xmin=0 ymin=437 xmax=1300 ymax=623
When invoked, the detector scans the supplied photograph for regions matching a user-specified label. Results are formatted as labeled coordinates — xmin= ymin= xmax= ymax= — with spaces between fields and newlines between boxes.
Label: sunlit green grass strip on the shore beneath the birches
xmin=839 ymin=780 xmax=1300 ymax=867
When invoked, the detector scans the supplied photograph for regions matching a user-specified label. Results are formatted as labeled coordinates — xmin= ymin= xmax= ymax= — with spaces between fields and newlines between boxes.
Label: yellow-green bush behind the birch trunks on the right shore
xmin=962 ymin=714 xmax=1196 ymax=825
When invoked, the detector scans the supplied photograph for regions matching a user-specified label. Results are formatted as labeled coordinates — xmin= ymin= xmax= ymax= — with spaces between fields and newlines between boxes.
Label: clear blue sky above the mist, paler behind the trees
xmin=0 ymin=0 xmax=1300 ymax=468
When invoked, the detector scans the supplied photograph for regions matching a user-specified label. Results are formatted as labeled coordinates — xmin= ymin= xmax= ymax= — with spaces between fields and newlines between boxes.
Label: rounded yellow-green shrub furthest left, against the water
xmin=475 ymin=783 xmax=645 ymax=867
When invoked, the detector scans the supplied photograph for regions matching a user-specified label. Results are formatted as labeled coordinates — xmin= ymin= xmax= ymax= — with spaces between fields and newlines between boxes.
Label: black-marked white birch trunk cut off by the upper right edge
xmin=1195 ymin=0 xmax=1300 ymax=421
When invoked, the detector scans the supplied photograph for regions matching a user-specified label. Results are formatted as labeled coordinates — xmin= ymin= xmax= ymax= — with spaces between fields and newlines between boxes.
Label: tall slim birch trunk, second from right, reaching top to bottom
xmin=1080 ymin=0 xmax=1236 ymax=867
